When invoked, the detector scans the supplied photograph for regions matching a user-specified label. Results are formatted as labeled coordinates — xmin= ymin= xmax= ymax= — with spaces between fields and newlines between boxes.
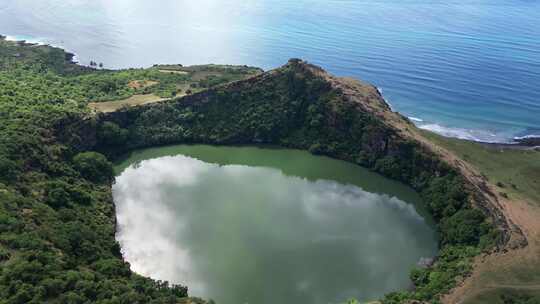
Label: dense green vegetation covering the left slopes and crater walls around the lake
xmin=0 ymin=39 xmax=497 ymax=303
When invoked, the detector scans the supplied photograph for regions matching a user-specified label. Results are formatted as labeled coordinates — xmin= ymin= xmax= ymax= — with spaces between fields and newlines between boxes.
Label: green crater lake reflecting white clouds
xmin=113 ymin=145 xmax=437 ymax=304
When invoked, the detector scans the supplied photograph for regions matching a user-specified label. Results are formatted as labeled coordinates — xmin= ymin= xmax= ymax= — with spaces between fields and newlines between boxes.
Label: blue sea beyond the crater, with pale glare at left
xmin=0 ymin=0 xmax=540 ymax=142
